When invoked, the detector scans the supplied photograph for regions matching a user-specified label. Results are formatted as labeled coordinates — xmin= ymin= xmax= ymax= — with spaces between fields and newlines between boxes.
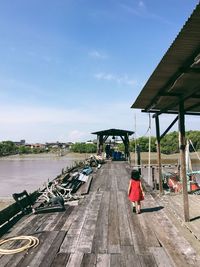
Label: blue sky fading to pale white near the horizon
xmin=0 ymin=0 xmax=200 ymax=143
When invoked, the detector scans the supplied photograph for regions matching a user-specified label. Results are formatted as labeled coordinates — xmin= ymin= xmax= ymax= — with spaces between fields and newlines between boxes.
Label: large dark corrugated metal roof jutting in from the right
xmin=132 ymin=4 xmax=200 ymax=115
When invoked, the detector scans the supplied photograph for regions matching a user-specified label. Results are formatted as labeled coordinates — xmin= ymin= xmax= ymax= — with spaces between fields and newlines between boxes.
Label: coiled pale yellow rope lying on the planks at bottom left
xmin=0 ymin=235 xmax=39 ymax=255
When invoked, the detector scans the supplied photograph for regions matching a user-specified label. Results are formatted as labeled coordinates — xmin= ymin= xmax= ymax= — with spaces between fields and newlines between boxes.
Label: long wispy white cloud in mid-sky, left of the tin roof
xmin=94 ymin=72 xmax=137 ymax=86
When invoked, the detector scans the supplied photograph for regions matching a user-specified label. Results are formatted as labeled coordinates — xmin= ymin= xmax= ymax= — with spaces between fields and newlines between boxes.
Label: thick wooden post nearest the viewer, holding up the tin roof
xmin=179 ymin=101 xmax=190 ymax=222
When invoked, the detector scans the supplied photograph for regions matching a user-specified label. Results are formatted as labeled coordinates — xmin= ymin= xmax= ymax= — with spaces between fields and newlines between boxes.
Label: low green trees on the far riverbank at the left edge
xmin=0 ymin=141 xmax=45 ymax=156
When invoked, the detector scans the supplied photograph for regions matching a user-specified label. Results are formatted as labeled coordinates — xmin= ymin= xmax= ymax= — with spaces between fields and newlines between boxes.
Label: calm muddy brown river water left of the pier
xmin=0 ymin=154 xmax=86 ymax=199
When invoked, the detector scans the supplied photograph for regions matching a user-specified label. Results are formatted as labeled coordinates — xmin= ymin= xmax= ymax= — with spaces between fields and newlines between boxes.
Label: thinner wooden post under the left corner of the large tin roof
xmin=155 ymin=115 xmax=163 ymax=195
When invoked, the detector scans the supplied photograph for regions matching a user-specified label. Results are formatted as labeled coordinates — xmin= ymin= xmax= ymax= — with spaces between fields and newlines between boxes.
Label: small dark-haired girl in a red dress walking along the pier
xmin=128 ymin=170 xmax=144 ymax=214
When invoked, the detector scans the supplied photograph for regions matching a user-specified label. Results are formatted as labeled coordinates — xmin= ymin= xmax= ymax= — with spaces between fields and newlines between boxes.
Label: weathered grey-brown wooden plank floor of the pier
xmin=0 ymin=162 xmax=200 ymax=267
